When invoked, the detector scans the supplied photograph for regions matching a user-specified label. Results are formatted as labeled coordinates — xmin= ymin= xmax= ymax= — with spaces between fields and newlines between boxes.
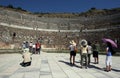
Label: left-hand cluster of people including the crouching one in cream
xmin=20 ymin=41 xmax=41 ymax=67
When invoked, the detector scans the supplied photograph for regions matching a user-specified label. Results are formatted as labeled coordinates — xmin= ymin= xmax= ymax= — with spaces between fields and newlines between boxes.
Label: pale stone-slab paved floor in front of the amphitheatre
xmin=0 ymin=52 xmax=120 ymax=78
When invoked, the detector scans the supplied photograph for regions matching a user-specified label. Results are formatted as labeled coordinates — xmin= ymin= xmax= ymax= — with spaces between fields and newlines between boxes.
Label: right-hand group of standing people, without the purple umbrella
xmin=69 ymin=39 xmax=113 ymax=72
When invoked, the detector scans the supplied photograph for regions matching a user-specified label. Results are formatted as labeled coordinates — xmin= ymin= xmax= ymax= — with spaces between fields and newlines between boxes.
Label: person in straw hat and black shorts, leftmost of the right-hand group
xmin=69 ymin=40 xmax=76 ymax=65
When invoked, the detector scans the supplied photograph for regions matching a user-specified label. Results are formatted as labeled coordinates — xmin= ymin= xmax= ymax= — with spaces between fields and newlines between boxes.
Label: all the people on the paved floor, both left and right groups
xmin=20 ymin=39 xmax=113 ymax=72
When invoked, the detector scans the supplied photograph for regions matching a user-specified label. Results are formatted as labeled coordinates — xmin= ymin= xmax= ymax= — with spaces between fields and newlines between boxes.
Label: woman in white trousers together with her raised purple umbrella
xmin=102 ymin=39 xmax=117 ymax=72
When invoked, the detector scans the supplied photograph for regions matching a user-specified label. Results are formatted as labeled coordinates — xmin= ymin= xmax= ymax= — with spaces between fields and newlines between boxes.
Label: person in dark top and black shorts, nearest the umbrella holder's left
xmin=92 ymin=41 xmax=100 ymax=64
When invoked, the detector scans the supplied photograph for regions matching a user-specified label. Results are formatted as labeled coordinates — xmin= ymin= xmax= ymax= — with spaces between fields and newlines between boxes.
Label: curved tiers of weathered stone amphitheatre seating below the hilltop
xmin=0 ymin=8 xmax=120 ymax=51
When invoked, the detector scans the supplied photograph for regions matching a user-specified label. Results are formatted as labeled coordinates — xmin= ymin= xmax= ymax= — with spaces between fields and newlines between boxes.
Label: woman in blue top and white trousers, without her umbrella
xmin=106 ymin=42 xmax=113 ymax=72
